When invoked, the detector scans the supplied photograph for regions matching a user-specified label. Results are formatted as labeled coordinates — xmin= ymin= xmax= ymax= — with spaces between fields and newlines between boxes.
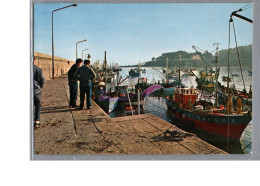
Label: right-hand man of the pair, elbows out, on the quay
xmin=74 ymin=60 xmax=96 ymax=110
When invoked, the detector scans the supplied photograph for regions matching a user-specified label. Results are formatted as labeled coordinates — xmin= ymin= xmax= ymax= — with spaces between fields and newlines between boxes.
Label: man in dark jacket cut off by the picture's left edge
xmin=33 ymin=58 xmax=45 ymax=129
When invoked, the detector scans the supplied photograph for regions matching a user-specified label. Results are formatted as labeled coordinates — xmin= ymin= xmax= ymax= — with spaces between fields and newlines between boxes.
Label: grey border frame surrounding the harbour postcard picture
xmin=30 ymin=0 xmax=260 ymax=160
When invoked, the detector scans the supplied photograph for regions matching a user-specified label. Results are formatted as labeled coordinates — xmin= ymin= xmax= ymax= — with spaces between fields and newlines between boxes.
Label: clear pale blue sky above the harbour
xmin=34 ymin=3 xmax=253 ymax=65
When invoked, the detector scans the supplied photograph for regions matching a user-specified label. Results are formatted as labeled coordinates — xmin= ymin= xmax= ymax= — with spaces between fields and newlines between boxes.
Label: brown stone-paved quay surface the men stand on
xmin=34 ymin=76 xmax=226 ymax=155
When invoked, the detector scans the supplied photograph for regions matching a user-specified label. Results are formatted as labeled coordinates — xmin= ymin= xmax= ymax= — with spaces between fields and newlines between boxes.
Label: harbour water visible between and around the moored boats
xmin=110 ymin=67 xmax=252 ymax=154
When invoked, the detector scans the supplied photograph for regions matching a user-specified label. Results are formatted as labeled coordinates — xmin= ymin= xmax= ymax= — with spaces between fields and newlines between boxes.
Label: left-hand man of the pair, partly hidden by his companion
xmin=68 ymin=59 xmax=82 ymax=108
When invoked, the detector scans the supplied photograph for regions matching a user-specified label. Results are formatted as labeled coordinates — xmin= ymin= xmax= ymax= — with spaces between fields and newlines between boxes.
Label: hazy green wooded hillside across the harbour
xmin=140 ymin=45 xmax=252 ymax=67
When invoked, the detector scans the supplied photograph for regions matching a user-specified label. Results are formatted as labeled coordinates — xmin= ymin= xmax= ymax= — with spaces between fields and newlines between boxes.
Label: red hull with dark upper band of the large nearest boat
xmin=166 ymin=99 xmax=252 ymax=140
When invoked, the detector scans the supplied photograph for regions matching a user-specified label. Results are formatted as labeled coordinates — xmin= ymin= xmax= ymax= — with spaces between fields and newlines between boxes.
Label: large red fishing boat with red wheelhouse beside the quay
xmin=166 ymin=88 xmax=252 ymax=139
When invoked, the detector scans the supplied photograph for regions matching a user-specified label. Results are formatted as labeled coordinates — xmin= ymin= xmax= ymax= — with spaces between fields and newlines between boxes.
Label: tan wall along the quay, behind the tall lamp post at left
xmin=34 ymin=52 xmax=75 ymax=79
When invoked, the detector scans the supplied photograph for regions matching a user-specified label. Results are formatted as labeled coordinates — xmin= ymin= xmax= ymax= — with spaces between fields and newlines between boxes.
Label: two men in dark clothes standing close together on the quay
xmin=68 ymin=59 xmax=96 ymax=110
